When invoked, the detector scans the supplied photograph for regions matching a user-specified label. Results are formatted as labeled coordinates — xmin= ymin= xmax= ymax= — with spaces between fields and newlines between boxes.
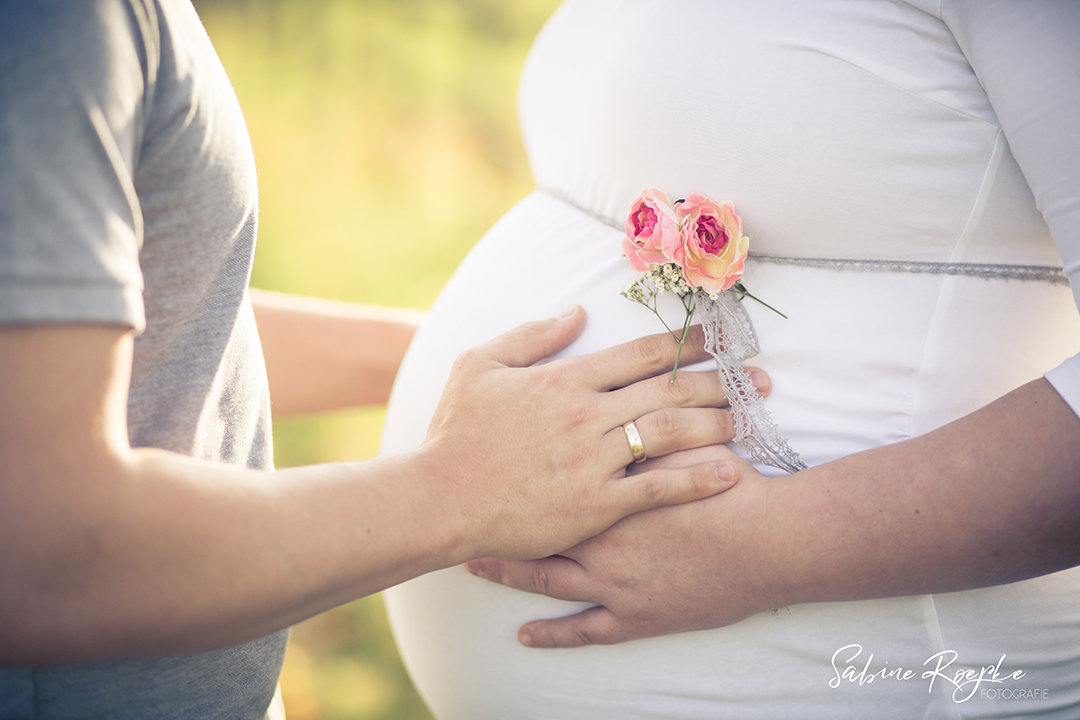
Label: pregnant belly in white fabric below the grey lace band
xmin=383 ymin=195 xmax=1080 ymax=720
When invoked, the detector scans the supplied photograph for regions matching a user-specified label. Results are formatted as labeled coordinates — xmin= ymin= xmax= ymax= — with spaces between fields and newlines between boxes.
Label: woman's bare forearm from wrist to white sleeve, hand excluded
xmin=747 ymin=380 xmax=1080 ymax=610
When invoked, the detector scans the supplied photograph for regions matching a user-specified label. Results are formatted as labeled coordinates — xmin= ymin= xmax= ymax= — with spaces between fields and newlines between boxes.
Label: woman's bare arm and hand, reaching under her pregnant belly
xmin=469 ymin=380 xmax=1080 ymax=648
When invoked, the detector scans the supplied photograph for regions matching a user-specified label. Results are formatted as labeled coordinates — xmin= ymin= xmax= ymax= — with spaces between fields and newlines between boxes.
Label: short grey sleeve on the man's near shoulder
xmin=0 ymin=0 xmax=153 ymax=330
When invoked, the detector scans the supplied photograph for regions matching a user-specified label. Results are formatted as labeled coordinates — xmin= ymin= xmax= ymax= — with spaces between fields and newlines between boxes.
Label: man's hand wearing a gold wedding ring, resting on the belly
xmin=420 ymin=307 xmax=760 ymax=559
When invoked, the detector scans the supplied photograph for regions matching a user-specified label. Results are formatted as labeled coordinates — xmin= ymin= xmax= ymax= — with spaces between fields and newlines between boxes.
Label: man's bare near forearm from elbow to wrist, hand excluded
xmin=0 ymin=450 xmax=467 ymax=663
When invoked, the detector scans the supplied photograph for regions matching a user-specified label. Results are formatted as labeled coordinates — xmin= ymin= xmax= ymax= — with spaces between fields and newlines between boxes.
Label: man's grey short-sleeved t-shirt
xmin=0 ymin=0 xmax=286 ymax=720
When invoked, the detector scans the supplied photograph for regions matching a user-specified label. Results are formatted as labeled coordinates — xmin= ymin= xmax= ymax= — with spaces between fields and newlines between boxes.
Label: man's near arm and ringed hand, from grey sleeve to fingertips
xmin=0 ymin=309 xmax=733 ymax=664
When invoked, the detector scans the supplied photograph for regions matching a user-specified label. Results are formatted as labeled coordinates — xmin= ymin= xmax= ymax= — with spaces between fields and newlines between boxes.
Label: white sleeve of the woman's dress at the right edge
xmin=942 ymin=0 xmax=1080 ymax=415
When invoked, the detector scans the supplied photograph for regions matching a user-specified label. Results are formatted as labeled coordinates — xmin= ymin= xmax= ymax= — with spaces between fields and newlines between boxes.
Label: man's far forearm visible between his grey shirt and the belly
xmin=251 ymin=289 xmax=423 ymax=417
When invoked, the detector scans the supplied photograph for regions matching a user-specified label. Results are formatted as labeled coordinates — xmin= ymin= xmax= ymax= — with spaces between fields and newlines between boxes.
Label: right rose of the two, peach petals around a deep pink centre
xmin=672 ymin=193 xmax=750 ymax=295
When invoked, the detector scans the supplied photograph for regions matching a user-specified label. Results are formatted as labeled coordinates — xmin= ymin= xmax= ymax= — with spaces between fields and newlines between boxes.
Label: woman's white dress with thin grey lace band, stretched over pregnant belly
xmin=383 ymin=0 xmax=1080 ymax=720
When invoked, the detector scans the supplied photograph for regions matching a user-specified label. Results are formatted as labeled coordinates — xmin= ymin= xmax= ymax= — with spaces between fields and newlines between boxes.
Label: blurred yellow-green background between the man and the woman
xmin=195 ymin=0 xmax=558 ymax=720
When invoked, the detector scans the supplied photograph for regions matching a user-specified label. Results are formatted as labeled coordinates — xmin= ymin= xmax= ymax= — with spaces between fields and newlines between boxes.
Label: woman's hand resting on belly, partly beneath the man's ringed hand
xmin=467 ymin=445 xmax=766 ymax=648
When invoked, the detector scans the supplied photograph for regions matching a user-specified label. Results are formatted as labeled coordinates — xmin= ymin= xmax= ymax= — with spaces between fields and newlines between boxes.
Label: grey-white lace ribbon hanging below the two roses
xmin=694 ymin=291 xmax=807 ymax=473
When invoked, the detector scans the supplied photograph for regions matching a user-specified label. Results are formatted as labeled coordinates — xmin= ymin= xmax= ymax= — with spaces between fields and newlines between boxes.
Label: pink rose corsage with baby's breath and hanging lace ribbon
xmin=622 ymin=189 xmax=806 ymax=473
